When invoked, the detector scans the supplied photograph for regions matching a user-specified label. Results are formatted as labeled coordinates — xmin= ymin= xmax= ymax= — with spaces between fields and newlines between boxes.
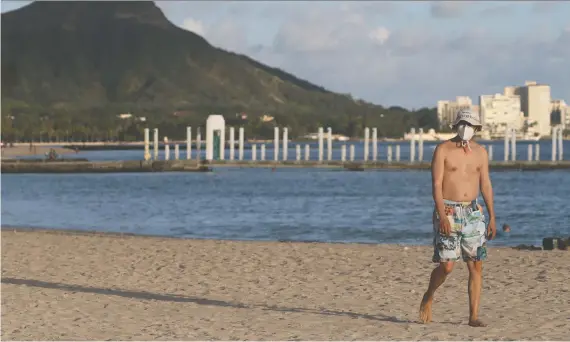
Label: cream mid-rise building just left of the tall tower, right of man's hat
xmin=479 ymin=93 xmax=524 ymax=136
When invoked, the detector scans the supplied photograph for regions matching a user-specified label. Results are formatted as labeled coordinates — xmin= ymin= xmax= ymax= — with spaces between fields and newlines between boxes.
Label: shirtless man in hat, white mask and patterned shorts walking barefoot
xmin=414 ymin=110 xmax=496 ymax=327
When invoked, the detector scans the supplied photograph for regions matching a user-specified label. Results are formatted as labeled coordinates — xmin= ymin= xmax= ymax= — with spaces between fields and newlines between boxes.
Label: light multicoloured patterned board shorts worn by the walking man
xmin=432 ymin=200 xmax=487 ymax=262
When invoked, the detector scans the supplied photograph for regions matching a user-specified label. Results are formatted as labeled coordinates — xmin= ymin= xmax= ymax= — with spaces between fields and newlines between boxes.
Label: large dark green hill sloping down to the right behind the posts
xmin=2 ymin=1 xmax=436 ymax=140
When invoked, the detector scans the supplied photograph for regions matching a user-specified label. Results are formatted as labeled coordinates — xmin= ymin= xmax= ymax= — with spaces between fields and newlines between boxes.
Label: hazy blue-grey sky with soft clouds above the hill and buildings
xmin=1 ymin=1 xmax=570 ymax=107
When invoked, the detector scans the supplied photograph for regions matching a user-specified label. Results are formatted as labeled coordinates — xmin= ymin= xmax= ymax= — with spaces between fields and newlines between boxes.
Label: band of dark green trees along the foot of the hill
xmin=1 ymin=101 xmax=438 ymax=142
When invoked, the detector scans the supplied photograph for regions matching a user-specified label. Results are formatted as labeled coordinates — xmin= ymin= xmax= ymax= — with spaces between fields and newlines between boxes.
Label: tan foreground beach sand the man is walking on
xmin=2 ymin=230 xmax=570 ymax=340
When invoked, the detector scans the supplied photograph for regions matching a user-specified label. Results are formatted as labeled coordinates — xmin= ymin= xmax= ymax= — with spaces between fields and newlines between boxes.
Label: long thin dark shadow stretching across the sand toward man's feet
xmin=2 ymin=277 xmax=408 ymax=323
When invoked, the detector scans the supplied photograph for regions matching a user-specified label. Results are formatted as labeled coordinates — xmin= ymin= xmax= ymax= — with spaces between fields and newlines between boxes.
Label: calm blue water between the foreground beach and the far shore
xmin=1 ymin=142 xmax=570 ymax=245
